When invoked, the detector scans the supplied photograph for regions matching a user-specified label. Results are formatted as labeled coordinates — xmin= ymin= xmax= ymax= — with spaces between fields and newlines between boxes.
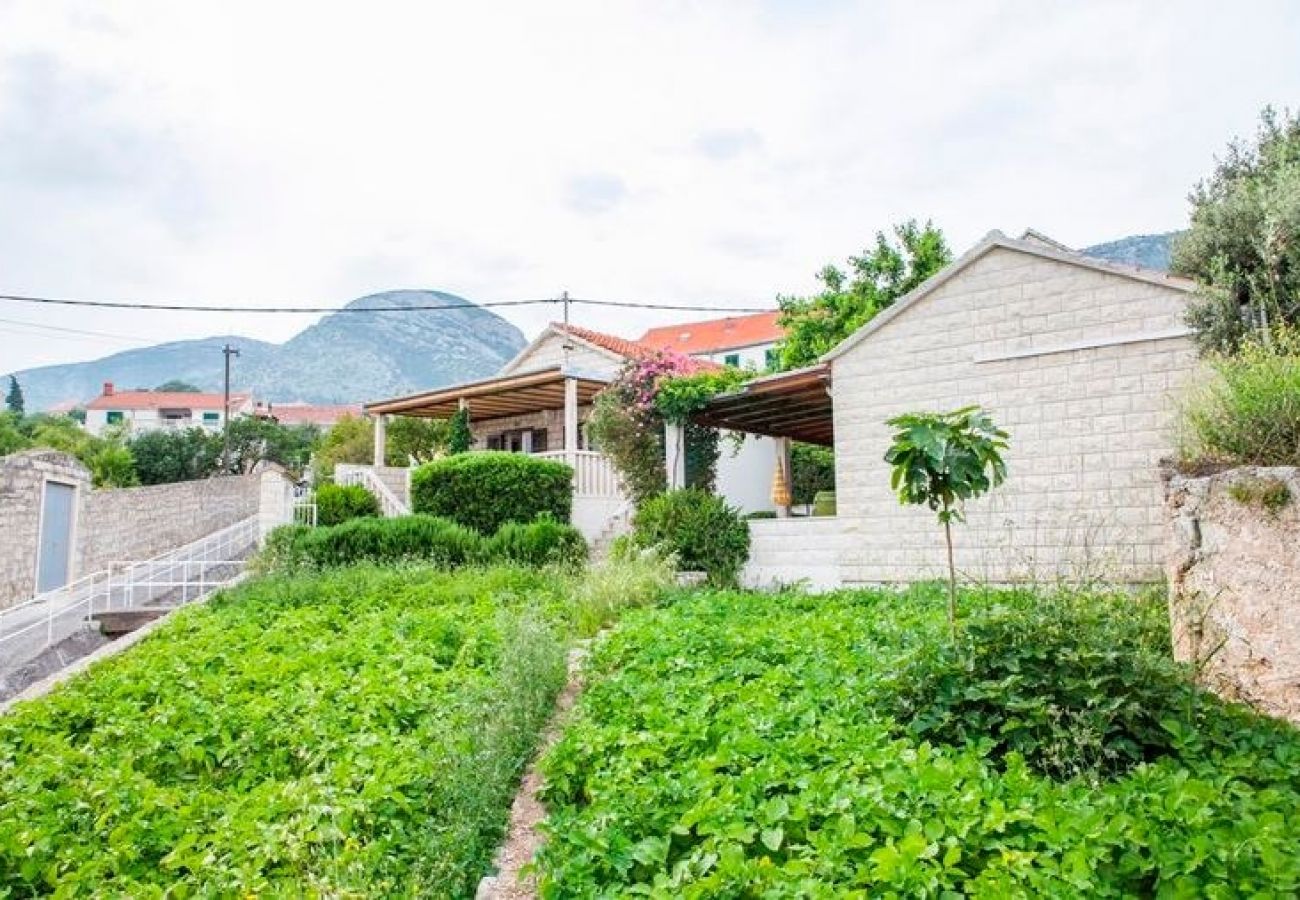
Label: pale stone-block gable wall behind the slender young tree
xmin=832 ymin=239 xmax=1196 ymax=583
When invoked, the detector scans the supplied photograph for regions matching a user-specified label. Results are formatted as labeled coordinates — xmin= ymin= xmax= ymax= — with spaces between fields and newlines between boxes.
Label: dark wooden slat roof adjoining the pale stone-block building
xmin=692 ymin=365 xmax=835 ymax=446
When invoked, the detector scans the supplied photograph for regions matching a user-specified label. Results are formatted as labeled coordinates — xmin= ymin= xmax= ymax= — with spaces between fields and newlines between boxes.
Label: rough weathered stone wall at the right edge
xmin=1166 ymin=468 xmax=1300 ymax=724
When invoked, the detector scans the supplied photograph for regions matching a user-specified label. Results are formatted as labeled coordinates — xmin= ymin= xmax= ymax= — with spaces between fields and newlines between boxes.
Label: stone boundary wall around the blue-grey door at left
xmin=0 ymin=450 xmax=261 ymax=609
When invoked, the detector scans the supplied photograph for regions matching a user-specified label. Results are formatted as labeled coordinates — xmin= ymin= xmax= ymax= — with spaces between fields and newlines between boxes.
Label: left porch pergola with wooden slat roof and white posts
xmin=364 ymin=365 xmax=610 ymax=466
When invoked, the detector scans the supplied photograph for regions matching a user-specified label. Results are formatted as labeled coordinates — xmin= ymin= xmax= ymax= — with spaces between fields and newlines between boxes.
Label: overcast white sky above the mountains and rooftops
xmin=0 ymin=0 xmax=1300 ymax=372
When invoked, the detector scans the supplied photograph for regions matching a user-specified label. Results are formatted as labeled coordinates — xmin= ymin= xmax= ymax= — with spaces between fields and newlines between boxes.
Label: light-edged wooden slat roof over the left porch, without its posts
xmin=365 ymin=365 xmax=608 ymax=421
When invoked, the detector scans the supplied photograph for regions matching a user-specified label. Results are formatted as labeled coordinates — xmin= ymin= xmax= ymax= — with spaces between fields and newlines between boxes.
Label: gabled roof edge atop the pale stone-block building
xmin=822 ymin=229 xmax=1196 ymax=363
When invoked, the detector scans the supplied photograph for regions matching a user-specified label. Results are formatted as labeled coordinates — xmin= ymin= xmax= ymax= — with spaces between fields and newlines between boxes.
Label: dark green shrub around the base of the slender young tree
xmin=894 ymin=596 xmax=1195 ymax=780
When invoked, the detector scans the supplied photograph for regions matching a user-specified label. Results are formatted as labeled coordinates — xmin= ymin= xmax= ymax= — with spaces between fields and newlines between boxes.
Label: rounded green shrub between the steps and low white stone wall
xmin=632 ymin=488 xmax=749 ymax=585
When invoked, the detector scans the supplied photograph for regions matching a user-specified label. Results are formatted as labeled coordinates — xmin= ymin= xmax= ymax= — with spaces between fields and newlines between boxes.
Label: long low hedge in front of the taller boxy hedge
xmin=261 ymin=515 xmax=586 ymax=571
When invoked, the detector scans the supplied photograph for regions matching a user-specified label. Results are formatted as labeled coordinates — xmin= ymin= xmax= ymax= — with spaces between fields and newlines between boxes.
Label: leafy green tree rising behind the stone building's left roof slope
xmin=776 ymin=218 xmax=953 ymax=369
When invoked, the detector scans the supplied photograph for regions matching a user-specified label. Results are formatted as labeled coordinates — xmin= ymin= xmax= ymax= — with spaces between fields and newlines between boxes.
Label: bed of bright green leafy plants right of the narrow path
xmin=540 ymin=587 xmax=1300 ymax=899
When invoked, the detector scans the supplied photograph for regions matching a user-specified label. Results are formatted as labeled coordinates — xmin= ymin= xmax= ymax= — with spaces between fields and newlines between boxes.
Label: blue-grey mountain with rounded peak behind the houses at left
xmin=6 ymin=290 xmax=525 ymax=410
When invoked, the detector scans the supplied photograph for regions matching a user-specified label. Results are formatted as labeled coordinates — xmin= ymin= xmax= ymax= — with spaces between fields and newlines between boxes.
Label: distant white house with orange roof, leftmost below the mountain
xmin=86 ymin=381 xmax=254 ymax=434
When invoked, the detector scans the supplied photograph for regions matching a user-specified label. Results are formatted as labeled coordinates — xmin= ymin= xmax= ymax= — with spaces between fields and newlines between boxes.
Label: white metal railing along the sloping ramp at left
xmin=0 ymin=515 xmax=260 ymax=668
